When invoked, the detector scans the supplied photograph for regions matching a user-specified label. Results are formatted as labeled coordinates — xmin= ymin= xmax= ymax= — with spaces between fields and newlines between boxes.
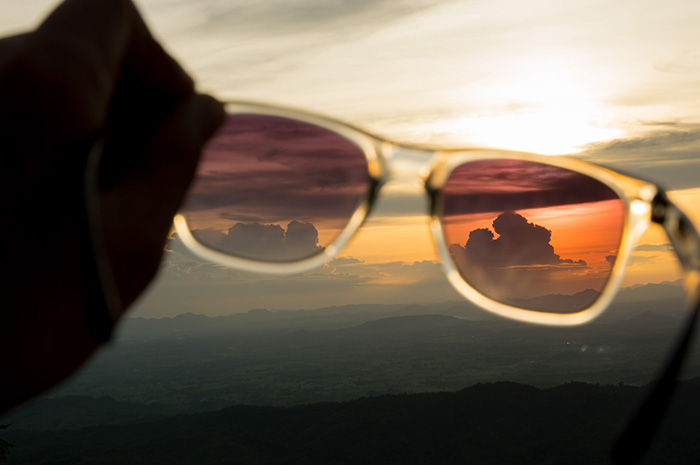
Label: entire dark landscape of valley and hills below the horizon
xmin=0 ymin=283 xmax=700 ymax=465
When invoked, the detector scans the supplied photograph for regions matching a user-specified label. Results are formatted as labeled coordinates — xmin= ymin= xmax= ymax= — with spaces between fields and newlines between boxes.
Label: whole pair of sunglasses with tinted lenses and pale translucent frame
xmin=174 ymin=102 xmax=700 ymax=463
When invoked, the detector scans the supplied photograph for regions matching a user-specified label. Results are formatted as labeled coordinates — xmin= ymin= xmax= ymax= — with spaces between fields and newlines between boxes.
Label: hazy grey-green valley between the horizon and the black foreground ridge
xmin=34 ymin=284 xmax=700 ymax=414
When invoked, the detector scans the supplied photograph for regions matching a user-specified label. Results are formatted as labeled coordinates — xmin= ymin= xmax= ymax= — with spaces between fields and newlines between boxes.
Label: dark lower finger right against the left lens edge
xmin=101 ymin=95 xmax=224 ymax=305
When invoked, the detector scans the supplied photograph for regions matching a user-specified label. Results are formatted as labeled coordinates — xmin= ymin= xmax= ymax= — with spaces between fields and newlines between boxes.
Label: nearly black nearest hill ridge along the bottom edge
xmin=3 ymin=382 xmax=700 ymax=465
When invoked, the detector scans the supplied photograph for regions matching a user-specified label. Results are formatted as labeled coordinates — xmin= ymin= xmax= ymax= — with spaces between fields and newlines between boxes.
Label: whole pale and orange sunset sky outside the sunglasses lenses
xmin=0 ymin=0 xmax=700 ymax=316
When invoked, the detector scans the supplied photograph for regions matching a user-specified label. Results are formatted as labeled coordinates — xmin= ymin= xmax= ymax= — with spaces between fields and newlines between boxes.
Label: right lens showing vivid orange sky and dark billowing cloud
xmin=441 ymin=160 xmax=625 ymax=313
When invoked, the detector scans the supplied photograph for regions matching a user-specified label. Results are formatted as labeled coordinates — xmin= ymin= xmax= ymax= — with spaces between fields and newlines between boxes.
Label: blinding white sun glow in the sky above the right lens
xmin=425 ymin=56 xmax=623 ymax=155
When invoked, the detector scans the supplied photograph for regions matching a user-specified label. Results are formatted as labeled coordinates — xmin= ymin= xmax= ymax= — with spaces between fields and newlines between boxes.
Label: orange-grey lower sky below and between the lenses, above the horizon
xmin=134 ymin=186 xmax=700 ymax=316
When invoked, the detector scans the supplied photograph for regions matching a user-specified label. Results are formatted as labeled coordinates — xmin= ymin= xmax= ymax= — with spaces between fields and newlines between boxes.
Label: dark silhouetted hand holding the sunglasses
xmin=0 ymin=0 xmax=224 ymax=412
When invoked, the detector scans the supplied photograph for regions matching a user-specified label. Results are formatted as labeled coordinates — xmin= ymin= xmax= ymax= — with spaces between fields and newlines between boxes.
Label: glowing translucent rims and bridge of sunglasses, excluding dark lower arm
xmin=174 ymin=102 xmax=700 ymax=326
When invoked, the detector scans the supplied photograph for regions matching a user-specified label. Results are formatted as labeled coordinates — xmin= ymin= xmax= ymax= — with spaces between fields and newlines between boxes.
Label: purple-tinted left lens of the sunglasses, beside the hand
xmin=183 ymin=114 xmax=370 ymax=262
